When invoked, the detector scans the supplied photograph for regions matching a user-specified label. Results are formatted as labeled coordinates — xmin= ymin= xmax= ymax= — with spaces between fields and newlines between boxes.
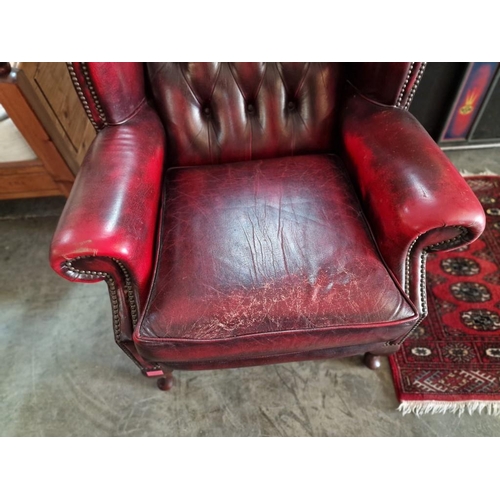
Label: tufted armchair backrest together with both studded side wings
xmin=69 ymin=62 xmax=424 ymax=166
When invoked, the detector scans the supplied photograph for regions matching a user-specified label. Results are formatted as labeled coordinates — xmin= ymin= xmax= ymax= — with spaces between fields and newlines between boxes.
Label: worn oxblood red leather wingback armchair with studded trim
xmin=51 ymin=63 xmax=485 ymax=389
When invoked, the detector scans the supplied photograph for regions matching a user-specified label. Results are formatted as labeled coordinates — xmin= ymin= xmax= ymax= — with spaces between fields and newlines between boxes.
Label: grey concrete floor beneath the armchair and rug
xmin=0 ymin=149 xmax=500 ymax=436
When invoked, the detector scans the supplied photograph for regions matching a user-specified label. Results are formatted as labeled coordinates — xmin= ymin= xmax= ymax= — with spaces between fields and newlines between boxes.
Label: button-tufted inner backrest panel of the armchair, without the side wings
xmin=143 ymin=63 xmax=342 ymax=166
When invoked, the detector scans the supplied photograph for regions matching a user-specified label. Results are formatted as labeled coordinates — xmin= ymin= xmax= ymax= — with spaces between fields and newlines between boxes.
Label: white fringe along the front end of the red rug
xmin=398 ymin=401 xmax=500 ymax=417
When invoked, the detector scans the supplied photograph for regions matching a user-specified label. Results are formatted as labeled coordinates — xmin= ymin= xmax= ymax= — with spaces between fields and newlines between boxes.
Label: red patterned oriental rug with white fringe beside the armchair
xmin=390 ymin=175 xmax=500 ymax=415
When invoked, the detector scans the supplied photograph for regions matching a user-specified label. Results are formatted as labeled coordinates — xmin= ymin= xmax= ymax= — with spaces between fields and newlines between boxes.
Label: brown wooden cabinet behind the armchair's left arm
xmin=0 ymin=62 xmax=95 ymax=199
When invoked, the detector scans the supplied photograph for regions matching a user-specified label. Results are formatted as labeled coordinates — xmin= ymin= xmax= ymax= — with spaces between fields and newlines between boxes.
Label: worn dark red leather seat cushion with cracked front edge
xmin=134 ymin=155 xmax=417 ymax=362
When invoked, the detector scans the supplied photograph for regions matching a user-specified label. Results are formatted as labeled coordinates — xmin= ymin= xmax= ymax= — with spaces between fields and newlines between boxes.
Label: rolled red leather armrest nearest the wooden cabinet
xmin=50 ymin=104 xmax=165 ymax=302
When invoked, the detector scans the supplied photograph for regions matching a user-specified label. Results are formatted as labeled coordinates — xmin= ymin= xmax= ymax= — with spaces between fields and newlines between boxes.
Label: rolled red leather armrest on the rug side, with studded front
xmin=341 ymin=94 xmax=485 ymax=315
